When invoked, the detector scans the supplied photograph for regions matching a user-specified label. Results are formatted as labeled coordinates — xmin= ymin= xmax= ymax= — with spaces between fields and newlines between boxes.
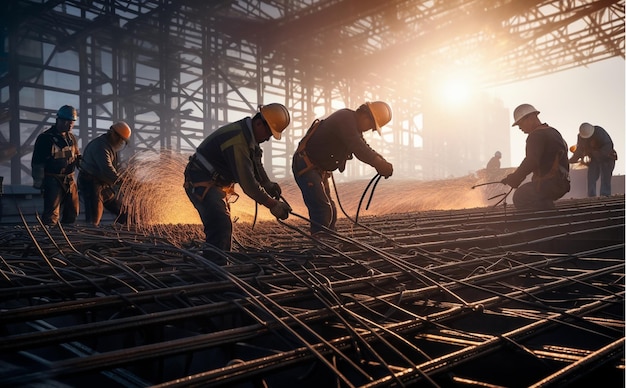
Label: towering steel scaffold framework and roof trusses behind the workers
xmin=0 ymin=0 xmax=624 ymax=184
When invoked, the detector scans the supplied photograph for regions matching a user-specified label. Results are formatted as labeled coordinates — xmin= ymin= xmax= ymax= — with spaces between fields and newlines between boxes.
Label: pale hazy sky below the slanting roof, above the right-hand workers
xmin=490 ymin=58 xmax=626 ymax=175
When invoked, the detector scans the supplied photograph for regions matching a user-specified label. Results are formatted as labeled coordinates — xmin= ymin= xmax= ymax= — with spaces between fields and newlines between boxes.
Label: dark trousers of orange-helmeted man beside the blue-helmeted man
xmin=78 ymin=172 xmax=128 ymax=226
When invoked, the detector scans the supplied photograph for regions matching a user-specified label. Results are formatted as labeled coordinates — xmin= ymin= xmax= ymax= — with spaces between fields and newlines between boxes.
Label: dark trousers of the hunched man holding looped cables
xmin=291 ymin=153 xmax=337 ymax=234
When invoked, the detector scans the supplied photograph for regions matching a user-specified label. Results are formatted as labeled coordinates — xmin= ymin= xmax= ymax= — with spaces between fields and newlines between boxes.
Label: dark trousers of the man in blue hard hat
xmin=41 ymin=174 xmax=79 ymax=225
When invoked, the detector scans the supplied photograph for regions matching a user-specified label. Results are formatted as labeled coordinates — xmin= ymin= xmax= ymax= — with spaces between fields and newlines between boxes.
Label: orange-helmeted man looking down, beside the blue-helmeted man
xmin=78 ymin=121 xmax=131 ymax=226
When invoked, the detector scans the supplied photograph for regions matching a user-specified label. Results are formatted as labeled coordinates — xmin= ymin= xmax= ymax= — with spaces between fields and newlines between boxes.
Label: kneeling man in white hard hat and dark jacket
xmin=502 ymin=104 xmax=570 ymax=210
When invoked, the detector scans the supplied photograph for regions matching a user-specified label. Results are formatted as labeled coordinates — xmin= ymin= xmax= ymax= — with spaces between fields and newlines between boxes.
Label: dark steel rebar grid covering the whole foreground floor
xmin=0 ymin=197 xmax=624 ymax=387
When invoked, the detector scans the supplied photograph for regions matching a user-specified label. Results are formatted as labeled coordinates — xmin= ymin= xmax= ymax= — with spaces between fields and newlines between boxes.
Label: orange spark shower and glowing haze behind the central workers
xmin=120 ymin=151 xmax=504 ymax=233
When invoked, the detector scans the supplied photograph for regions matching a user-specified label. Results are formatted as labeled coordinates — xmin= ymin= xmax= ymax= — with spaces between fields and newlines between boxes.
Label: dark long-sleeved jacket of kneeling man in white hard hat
xmin=507 ymin=124 xmax=569 ymax=187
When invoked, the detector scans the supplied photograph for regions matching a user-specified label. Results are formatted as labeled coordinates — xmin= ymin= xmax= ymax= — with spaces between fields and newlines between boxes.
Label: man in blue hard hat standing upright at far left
xmin=31 ymin=105 xmax=80 ymax=226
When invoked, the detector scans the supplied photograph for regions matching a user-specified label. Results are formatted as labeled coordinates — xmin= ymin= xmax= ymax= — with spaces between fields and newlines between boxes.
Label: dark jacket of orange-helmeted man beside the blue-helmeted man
xmin=80 ymin=133 xmax=119 ymax=185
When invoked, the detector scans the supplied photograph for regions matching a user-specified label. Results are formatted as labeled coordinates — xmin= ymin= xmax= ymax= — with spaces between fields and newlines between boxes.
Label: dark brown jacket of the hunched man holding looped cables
xmin=305 ymin=109 xmax=382 ymax=172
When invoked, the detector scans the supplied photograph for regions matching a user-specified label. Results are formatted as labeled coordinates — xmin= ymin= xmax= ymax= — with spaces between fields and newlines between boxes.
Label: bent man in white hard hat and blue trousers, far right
xmin=569 ymin=123 xmax=617 ymax=197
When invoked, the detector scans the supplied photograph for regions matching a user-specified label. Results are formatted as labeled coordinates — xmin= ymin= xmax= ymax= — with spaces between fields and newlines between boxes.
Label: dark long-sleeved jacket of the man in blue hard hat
xmin=31 ymin=125 xmax=80 ymax=182
